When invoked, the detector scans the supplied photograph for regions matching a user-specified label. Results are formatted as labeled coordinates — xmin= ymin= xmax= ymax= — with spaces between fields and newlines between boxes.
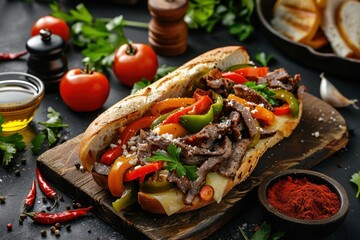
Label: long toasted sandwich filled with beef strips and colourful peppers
xmin=79 ymin=46 xmax=304 ymax=215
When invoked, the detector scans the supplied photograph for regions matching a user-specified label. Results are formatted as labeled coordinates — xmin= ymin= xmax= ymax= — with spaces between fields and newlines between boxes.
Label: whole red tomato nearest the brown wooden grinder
xmin=113 ymin=43 xmax=158 ymax=86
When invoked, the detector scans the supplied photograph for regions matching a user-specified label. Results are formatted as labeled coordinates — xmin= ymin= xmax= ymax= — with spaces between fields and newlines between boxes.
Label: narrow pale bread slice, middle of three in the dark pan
xmin=321 ymin=0 xmax=354 ymax=57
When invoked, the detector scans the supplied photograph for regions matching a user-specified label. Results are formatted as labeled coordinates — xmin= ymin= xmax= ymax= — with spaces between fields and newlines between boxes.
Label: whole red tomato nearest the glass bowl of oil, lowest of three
xmin=59 ymin=68 xmax=110 ymax=112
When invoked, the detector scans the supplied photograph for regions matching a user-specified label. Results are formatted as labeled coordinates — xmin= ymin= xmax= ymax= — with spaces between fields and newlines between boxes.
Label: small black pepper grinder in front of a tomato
xmin=26 ymin=29 xmax=67 ymax=86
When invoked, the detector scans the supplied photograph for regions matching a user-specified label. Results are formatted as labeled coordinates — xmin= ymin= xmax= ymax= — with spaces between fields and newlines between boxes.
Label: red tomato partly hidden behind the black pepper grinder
xmin=31 ymin=16 xmax=70 ymax=42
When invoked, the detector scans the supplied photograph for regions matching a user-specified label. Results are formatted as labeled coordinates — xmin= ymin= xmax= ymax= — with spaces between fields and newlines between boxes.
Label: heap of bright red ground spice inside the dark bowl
xmin=267 ymin=176 xmax=340 ymax=220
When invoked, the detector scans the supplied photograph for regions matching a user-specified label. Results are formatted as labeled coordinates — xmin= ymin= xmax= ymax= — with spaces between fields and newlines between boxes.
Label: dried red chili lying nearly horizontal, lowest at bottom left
xmin=25 ymin=206 xmax=92 ymax=224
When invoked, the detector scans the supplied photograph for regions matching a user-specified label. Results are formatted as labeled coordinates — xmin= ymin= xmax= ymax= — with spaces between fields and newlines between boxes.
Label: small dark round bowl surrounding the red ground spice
xmin=258 ymin=169 xmax=349 ymax=239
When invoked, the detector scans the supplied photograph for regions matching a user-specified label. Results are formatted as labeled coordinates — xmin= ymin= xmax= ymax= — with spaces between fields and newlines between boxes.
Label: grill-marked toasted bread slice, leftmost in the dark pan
xmin=271 ymin=0 xmax=321 ymax=42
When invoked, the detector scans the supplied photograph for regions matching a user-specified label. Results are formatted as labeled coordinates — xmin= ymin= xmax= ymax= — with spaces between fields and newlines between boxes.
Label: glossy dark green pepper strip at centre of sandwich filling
xmin=180 ymin=105 xmax=214 ymax=133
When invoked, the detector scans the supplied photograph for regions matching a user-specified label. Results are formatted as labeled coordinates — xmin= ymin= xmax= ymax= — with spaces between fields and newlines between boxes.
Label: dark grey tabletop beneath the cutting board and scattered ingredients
xmin=0 ymin=0 xmax=360 ymax=240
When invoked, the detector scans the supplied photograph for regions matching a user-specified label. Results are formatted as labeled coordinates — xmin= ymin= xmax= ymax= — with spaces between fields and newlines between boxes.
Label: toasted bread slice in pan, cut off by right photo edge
xmin=337 ymin=0 xmax=360 ymax=58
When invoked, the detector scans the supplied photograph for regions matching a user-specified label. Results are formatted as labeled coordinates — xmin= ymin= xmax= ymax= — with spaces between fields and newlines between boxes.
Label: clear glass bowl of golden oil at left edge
xmin=0 ymin=72 xmax=45 ymax=132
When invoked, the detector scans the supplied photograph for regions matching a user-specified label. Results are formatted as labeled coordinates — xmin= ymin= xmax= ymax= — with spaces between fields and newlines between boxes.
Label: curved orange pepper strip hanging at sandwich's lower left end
xmin=108 ymin=156 xmax=136 ymax=197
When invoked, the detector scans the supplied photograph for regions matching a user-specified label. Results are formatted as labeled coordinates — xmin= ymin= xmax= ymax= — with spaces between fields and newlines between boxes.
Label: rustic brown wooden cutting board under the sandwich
xmin=38 ymin=94 xmax=348 ymax=239
